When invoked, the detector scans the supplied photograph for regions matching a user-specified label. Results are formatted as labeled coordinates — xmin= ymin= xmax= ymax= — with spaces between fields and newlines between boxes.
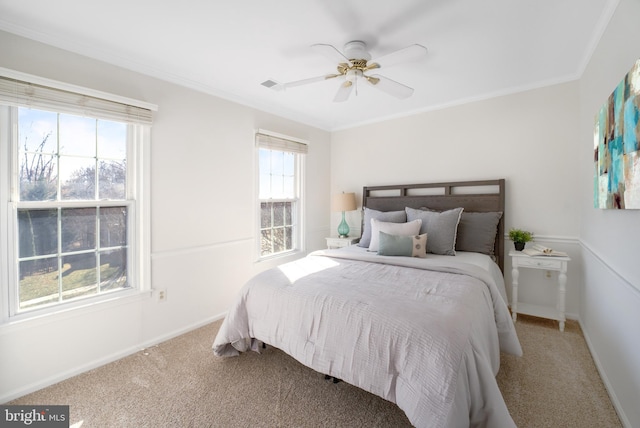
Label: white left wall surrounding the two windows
xmin=0 ymin=32 xmax=330 ymax=402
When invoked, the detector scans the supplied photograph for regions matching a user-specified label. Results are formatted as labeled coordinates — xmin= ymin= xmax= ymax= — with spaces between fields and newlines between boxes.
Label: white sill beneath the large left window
xmin=0 ymin=290 xmax=152 ymax=336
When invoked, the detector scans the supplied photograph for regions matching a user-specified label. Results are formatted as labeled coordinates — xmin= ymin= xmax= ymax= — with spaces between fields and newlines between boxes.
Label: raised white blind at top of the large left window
xmin=0 ymin=76 xmax=153 ymax=125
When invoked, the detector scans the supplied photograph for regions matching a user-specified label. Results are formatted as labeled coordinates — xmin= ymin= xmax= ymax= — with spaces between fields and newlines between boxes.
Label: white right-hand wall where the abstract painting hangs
xmin=577 ymin=0 xmax=640 ymax=427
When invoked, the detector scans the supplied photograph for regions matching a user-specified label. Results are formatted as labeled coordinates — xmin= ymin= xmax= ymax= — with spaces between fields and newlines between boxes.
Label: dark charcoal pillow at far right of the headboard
xmin=456 ymin=212 xmax=502 ymax=256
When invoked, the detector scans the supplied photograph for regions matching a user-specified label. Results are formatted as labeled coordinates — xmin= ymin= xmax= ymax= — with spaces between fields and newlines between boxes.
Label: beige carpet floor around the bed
xmin=7 ymin=316 xmax=621 ymax=428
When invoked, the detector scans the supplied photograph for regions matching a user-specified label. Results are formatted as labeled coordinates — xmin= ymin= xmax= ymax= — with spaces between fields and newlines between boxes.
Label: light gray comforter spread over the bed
xmin=213 ymin=250 xmax=522 ymax=427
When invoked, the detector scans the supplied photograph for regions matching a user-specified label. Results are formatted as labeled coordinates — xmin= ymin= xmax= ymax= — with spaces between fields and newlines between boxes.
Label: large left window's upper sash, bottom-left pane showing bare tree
xmin=19 ymin=152 xmax=58 ymax=201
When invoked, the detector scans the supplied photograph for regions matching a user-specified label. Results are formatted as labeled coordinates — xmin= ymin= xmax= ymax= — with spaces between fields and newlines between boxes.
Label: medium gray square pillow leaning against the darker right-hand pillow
xmin=404 ymin=207 xmax=463 ymax=256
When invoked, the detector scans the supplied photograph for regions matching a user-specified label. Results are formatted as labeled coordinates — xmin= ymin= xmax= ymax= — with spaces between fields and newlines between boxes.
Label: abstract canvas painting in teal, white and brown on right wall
xmin=594 ymin=59 xmax=640 ymax=209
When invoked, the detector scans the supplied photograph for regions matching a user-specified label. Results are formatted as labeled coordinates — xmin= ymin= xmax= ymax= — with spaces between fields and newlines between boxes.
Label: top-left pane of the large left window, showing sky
xmin=18 ymin=107 xmax=58 ymax=154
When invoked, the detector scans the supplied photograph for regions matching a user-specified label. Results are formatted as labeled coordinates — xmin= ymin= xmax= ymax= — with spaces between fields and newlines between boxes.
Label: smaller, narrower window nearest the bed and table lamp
xmin=256 ymin=131 xmax=307 ymax=258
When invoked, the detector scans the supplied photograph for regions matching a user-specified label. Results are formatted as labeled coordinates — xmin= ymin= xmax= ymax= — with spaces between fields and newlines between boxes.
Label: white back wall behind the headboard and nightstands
xmin=331 ymin=82 xmax=580 ymax=318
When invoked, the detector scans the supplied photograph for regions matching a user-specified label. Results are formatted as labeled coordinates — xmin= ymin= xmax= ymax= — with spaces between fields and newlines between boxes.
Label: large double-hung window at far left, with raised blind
xmin=0 ymin=72 xmax=151 ymax=317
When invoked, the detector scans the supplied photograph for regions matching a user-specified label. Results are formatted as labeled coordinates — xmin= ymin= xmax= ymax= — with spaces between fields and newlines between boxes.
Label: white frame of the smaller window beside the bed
xmin=254 ymin=129 xmax=309 ymax=262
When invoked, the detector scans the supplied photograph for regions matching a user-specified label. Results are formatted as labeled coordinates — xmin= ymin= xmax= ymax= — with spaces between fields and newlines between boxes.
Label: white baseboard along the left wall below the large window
xmin=0 ymin=312 xmax=226 ymax=403
